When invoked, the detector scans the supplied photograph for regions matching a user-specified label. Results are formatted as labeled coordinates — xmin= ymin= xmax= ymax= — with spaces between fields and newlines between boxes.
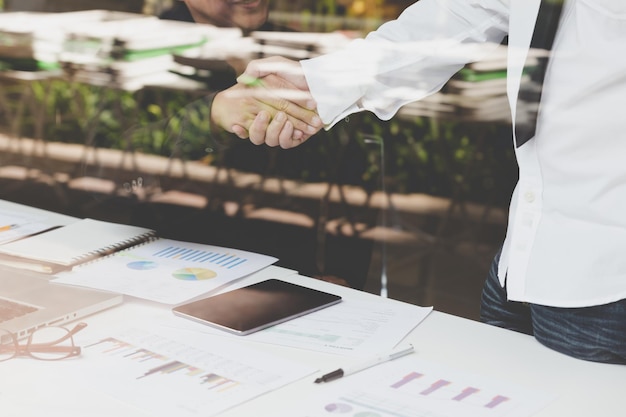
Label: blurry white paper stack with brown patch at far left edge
xmin=0 ymin=10 xmax=141 ymax=71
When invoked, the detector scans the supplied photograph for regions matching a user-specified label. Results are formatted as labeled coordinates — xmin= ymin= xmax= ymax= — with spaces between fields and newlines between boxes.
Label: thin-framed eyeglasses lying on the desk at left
xmin=0 ymin=323 xmax=87 ymax=362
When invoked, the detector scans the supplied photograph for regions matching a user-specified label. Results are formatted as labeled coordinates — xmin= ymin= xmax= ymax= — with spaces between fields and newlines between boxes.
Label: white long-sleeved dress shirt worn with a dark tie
xmin=302 ymin=0 xmax=626 ymax=307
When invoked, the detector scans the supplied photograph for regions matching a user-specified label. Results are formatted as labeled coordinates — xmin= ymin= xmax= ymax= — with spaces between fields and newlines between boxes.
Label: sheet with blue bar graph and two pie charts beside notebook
xmin=54 ymin=239 xmax=277 ymax=304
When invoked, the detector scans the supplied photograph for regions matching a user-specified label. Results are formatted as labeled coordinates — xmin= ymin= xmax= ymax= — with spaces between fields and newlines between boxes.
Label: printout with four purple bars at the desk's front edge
xmin=279 ymin=357 xmax=549 ymax=417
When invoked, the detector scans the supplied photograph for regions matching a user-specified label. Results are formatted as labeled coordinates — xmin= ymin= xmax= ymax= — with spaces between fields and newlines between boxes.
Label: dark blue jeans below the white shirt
xmin=480 ymin=249 xmax=626 ymax=364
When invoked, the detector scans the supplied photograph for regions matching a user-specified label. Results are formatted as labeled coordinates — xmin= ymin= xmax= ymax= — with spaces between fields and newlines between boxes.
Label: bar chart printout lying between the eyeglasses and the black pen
xmin=76 ymin=329 xmax=315 ymax=417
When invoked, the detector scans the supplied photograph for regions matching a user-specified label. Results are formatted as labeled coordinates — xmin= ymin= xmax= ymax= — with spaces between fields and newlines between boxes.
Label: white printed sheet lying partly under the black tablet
xmin=167 ymin=298 xmax=432 ymax=357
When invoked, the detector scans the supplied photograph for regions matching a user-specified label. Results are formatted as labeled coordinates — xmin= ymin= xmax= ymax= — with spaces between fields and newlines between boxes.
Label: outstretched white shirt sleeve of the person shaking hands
xmin=301 ymin=0 xmax=509 ymax=129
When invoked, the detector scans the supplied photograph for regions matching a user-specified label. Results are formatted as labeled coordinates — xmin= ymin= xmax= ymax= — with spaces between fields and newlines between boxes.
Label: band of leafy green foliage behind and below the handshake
xmin=4 ymin=80 xmax=517 ymax=206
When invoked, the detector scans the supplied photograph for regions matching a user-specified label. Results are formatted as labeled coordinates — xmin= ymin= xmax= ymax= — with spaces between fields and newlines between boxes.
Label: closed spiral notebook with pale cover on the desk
xmin=0 ymin=219 xmax=155 ymax=272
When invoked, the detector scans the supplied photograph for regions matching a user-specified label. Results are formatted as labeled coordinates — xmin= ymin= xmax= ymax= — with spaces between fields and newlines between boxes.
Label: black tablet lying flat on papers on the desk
xmin=172 ymin=279 xmax=341 ymax=335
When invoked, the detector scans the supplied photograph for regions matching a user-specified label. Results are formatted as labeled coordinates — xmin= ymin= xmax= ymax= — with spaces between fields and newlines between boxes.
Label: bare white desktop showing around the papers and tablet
xmin=0 ymin=199 xmax=626 ymax=417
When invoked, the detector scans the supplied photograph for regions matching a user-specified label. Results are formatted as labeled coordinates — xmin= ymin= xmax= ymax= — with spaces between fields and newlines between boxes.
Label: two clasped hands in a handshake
xmin=211 ymin=57 xmax=323 ymax=149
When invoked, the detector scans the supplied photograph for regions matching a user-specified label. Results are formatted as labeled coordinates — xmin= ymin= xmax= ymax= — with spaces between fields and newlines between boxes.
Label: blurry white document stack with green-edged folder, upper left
xmin=60 ymin=15 xmax=213 ymax=90
